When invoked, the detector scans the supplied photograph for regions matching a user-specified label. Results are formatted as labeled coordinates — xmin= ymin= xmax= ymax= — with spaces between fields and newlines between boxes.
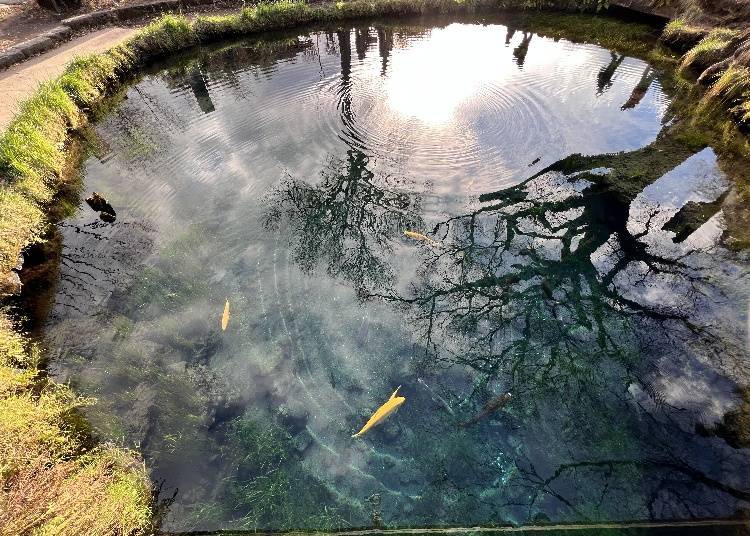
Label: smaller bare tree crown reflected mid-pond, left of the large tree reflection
xmin=266 ymin=150 xmax=420 ymax=296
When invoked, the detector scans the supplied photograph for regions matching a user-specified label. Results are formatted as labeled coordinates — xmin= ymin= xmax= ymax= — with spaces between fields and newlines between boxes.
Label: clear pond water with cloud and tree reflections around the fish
xmin=45 ymin=15 xmax=750 ymax=530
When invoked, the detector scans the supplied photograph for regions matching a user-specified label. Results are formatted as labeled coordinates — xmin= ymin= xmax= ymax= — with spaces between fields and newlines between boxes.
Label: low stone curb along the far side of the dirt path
xmin=0 ymin=0 xmax=222 ymax=70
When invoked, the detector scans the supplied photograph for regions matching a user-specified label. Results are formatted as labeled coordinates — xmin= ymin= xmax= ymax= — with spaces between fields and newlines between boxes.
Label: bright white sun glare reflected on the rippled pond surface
xmin=386 ymin=24 xmax=515 ymax=124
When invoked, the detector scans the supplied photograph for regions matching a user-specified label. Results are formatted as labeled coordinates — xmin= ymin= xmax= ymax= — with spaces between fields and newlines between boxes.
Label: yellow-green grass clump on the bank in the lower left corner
xmin=0 ymin=313 xmax=152 ymax=536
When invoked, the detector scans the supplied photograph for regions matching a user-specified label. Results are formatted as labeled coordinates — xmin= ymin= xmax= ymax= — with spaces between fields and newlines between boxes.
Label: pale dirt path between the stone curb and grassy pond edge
xmin=0 ymin=27 xmax=137 ymax=131
